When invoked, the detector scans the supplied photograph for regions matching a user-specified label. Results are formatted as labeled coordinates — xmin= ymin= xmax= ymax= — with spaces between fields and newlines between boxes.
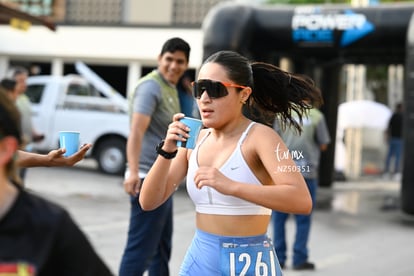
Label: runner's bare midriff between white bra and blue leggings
xmin=196 ymin=213 xmax=270 ymax=236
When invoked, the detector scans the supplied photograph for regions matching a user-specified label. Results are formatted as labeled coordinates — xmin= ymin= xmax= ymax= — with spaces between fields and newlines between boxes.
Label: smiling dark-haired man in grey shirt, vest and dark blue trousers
xmin=119 ymin=37 xmax=190 ymax=276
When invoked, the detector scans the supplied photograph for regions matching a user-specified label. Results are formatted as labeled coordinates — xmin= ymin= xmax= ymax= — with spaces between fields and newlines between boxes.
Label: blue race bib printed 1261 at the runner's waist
xmin=220 ymin=238 xmax=282 ymax=276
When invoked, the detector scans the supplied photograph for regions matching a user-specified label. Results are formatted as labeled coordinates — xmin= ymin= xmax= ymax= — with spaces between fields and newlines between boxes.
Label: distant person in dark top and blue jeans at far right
xmin=384 ymin=103 xmax=403 ymax=179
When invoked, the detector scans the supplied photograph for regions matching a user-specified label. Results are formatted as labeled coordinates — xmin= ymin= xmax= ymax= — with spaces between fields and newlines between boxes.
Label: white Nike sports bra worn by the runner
xmin=187 ymin=122 xmax=272 ymax=215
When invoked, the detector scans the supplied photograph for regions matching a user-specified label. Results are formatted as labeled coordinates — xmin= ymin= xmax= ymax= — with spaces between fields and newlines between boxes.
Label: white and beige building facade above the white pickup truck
xmin=0 ymin=0 xmax=228 ymax=95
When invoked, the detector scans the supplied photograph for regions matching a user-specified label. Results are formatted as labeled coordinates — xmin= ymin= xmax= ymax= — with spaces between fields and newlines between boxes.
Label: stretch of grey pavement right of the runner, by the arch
xmin=278 ymin=178 xmax=414 ymax=276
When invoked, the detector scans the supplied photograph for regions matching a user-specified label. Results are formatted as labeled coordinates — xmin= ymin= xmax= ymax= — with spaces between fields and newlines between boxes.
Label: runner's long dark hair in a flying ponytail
xmin=203 ymin=51 xmax=323 ymax=131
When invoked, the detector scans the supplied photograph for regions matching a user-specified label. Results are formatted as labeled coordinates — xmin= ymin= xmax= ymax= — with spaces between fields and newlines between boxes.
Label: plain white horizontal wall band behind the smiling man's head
xmin=0 ymin=25 xmax=203 ymax=72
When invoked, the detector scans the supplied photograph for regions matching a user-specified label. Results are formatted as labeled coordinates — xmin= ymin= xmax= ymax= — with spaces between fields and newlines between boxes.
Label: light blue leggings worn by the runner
xmin=179 ymin=229 xmax=282 ymax=276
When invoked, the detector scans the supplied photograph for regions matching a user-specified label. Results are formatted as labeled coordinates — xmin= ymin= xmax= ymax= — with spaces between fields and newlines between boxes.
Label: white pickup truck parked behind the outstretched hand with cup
xmin=26 ymin=75 xmax=129 ymax=174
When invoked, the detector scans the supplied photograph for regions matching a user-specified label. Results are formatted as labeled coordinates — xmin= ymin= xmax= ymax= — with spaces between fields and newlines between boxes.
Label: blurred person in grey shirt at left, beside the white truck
xmin=7 ymin=67 xmax=44 ymax=180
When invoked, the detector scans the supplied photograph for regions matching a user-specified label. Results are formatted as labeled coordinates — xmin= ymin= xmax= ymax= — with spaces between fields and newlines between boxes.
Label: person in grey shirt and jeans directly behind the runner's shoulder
xmin=272 ymin=105 xmax=331 ymax=270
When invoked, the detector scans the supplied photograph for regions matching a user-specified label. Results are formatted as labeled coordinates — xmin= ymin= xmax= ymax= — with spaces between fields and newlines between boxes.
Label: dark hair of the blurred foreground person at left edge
xmin=0 ymin=93 xmax=22 ymax=183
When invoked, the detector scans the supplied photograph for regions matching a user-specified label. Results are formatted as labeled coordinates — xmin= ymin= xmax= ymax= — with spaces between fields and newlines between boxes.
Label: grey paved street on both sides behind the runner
xmin=26 ymin=161 xmax=414 ymax=276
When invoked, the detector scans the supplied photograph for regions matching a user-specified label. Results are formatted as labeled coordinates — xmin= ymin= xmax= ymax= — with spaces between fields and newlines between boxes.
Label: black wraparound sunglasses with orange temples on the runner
xmin=191 ymin=80 xmax=247 ymax=99
